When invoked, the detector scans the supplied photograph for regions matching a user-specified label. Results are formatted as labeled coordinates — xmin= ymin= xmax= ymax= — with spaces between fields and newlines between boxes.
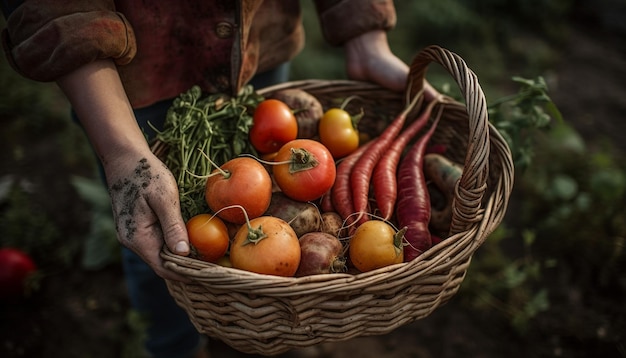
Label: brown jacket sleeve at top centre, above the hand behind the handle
xmin=315 ymin=0 xmax=396 ymax=45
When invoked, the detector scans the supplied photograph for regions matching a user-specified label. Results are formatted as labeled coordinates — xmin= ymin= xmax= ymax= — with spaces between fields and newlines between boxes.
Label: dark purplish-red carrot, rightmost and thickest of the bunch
xmin=396 ymin=105 xmax=441 ymax=262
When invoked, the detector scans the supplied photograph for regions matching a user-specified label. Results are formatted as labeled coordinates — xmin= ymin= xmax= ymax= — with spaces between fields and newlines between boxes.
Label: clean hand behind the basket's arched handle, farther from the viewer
xmin=344 ymin=30 xmax=437 ymax=101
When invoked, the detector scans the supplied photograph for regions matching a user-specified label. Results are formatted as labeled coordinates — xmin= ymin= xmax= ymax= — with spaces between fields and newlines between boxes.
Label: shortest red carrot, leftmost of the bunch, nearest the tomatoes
xmin=330 ymin=142 xmax=373 ymax=222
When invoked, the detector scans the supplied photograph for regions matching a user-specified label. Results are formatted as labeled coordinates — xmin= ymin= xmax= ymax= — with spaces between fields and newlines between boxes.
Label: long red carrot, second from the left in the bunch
xmin=350 ymin=92 xmax=422 ymax=221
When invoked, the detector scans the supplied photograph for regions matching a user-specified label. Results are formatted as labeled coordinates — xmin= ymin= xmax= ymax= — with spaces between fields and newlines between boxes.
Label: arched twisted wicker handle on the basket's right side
xmin=407 ymin=46 xmax=490 ymax=235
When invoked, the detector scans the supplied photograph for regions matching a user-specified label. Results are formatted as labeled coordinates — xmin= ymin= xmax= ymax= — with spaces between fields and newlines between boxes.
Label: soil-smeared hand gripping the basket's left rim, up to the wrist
xmin=105 ymin=152 xmax=189 ymax=280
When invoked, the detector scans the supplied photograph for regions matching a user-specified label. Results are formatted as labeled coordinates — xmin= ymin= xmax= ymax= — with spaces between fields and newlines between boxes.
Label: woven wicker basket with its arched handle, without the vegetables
xmin=162 ymin=46 xmax=513 ymax=355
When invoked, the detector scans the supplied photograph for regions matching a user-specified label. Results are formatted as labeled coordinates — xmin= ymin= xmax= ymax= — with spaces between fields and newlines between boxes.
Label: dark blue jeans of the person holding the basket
xmin=122 ymin=64 xmax=289 ymax=358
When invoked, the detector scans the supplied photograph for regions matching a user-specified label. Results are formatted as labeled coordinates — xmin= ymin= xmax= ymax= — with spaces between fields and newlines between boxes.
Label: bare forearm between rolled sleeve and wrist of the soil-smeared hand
xmin=57 ymin=60 xmax=149 ymax=167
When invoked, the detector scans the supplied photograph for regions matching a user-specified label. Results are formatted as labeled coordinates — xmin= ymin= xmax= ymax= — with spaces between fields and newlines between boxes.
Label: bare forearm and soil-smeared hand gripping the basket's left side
xmin=57 ymin=60 xmax=189 ymax=280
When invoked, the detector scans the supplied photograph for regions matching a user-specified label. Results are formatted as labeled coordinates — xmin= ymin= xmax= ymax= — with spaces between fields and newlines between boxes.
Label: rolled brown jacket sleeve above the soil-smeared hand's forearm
xmin=2 ymin=0 xmax=136 ymax=81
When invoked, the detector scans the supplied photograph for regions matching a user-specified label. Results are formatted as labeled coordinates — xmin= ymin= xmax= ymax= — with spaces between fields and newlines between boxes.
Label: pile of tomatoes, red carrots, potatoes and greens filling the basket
xmin=152 ymin=87 xmax=462 ymax=277
